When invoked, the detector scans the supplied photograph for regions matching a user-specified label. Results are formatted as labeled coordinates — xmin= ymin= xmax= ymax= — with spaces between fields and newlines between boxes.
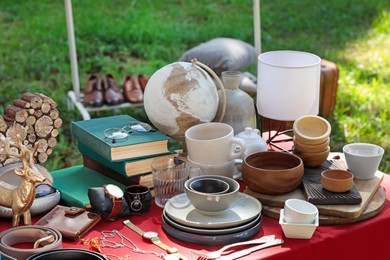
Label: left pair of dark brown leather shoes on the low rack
xmin=83 ymin=74 xmax=124 ymax=107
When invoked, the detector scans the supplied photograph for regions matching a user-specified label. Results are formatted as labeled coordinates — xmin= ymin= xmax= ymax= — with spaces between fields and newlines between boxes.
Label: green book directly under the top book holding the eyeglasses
xmin=77 ymin=142 xmax=176 ymax=177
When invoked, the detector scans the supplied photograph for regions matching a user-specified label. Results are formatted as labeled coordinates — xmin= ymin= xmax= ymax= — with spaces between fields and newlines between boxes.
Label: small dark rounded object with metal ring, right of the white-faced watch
xmin=124 ymin=185 xmax=152 ymax=213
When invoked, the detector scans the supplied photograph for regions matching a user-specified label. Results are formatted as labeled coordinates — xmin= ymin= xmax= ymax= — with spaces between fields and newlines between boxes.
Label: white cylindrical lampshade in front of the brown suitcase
xmin=257 ymin=50 xmax=321 ymax=121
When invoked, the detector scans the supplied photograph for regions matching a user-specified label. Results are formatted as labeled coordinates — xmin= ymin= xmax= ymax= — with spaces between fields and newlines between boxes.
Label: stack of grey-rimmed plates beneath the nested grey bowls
xmin=162 ymin=193 xmax=262 ymax=245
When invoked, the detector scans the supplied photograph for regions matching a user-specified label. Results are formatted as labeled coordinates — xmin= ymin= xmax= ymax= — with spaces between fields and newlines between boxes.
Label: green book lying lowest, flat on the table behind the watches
xmin=50 ymin=165 xmax=126 ymax=208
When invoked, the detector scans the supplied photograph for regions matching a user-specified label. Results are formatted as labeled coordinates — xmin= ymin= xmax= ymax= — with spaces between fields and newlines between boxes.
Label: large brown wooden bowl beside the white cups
xmin=241 ymin=151 xmax=303 ymax=194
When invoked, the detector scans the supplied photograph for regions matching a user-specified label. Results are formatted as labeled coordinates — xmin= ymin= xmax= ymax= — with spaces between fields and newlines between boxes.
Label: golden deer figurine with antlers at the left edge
xmin=0 ymin=135 xmax=45 ymax=227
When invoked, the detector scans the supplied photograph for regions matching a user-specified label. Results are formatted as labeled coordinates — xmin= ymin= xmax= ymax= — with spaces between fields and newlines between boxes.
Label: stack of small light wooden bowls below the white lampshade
xmin=293 ymin=115 xmax=331 ymax=167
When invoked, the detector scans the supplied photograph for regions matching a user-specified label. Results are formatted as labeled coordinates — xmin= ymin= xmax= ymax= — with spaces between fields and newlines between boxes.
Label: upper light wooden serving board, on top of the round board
xmin=244 ymin=171 xmax=383 ymax=219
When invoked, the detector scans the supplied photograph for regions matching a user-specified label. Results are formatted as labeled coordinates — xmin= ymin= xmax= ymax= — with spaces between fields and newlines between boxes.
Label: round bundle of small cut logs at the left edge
xmin=0 ymin=92 xmax=63 ymax=166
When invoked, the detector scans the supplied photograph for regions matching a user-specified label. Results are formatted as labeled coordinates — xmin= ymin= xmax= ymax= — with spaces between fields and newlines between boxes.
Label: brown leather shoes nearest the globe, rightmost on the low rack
xmin=123 ymin=74 xmax=149 ymax=103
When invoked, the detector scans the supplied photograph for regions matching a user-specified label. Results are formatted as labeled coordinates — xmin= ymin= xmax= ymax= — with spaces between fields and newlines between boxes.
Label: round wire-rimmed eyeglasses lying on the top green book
xmin=104 ymin=121 xmax=155 ymax=143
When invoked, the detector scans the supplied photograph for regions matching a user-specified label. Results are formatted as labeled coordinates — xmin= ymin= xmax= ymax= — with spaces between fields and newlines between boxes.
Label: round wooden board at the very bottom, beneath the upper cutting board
xmin=261 ymin=187 xmax=386 ymax=226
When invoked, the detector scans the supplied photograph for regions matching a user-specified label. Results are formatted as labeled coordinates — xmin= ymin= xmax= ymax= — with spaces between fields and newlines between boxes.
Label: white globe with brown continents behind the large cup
xmin=144 ymin=62 xmax=219 ymax=141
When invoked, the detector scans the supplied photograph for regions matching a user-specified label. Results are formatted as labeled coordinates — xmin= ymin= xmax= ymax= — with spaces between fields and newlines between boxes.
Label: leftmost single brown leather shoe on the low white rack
xmin=83 ymin=75 xmax=103 ymax=107
